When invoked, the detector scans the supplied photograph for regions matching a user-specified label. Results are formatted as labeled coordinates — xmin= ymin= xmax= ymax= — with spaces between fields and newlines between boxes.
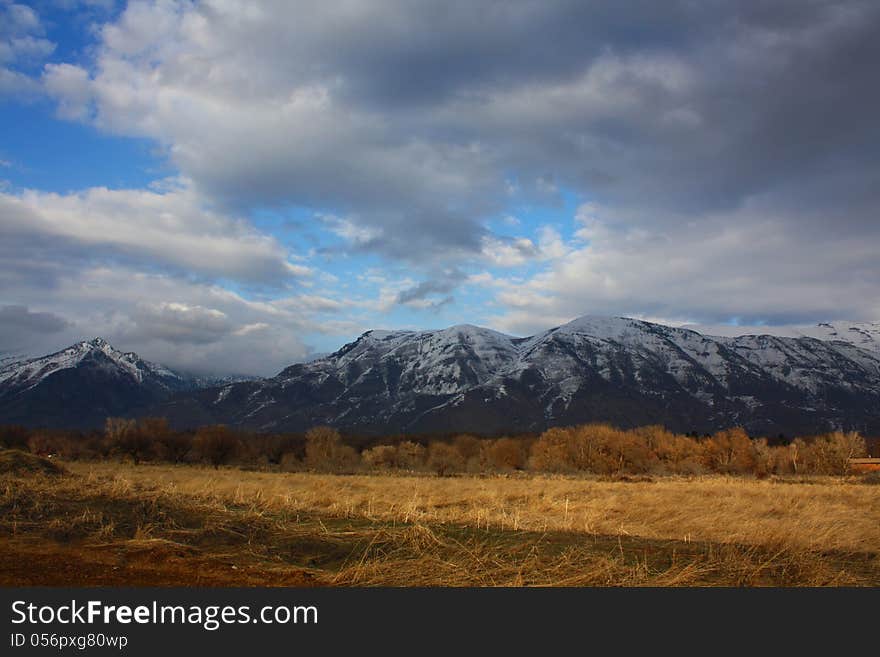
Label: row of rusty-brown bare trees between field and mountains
xmin=0 ymin=417 xmax=877 ymax=477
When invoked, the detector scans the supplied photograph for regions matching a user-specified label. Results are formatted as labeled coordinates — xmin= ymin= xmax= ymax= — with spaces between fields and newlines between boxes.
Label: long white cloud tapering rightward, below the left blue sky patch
xmin=0 ymin=179 xmax=311 ymax=286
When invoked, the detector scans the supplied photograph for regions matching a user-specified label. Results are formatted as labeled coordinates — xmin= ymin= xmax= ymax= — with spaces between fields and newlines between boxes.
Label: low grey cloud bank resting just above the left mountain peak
xmin=0 ymin=265 xmax=324 ymax=375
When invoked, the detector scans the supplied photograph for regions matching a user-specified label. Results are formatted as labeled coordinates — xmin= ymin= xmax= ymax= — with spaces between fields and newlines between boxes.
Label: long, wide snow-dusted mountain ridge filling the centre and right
xmin=161 ymin=317 xmax=880 ymax=433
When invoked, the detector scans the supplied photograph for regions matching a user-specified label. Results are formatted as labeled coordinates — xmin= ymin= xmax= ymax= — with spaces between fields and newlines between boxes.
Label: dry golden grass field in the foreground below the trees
xmin=0 ymin=452 xmax=880 ymax=586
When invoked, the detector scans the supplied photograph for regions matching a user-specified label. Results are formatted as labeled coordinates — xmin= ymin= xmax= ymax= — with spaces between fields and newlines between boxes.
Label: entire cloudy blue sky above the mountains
xmin=0 ymin=0 xmax=880 ymax=375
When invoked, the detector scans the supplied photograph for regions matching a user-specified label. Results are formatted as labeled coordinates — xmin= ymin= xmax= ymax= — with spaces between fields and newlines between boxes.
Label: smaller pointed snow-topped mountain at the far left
xmin=0 ymin=338 xmax=254 ymax=428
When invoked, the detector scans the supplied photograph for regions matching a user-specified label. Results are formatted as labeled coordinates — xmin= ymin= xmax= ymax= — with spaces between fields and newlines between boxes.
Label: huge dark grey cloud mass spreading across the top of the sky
xmin=44 ymin=0 xmax=880 ymax=269
